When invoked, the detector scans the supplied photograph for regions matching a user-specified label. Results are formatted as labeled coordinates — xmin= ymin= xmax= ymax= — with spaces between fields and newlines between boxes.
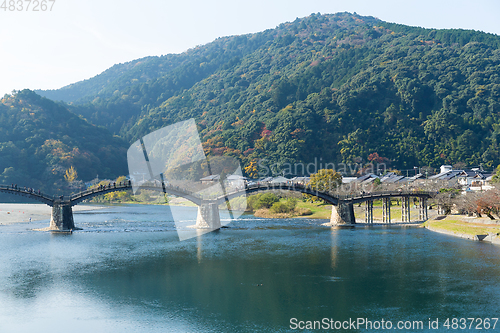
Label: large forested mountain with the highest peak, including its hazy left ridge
xmin=19 ymin=13 xmax=500 ymax=180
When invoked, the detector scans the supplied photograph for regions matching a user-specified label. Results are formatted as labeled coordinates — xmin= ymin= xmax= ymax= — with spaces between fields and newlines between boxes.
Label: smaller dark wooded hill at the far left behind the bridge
xmin=0 ymin=90 xmax=128 ymax=193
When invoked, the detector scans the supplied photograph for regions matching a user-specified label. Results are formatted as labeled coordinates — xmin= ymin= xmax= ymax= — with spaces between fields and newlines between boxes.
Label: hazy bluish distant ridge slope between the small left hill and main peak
xmin=37 ymin=31 xmax=282 ymax=136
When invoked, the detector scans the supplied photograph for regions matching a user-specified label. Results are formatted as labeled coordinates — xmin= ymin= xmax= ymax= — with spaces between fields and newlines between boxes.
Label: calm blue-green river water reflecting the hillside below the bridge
xmin=0 ymin=206 xmax=500 ymax=333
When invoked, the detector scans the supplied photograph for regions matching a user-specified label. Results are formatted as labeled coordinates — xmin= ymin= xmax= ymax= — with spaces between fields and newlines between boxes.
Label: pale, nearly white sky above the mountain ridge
xmin=0 ymin=0 xmax=500 ymax=96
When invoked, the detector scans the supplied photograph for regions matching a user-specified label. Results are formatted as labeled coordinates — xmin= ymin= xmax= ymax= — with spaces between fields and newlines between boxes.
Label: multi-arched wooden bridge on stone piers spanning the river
xmin=0 ymin=181 xmax=436 ymax=231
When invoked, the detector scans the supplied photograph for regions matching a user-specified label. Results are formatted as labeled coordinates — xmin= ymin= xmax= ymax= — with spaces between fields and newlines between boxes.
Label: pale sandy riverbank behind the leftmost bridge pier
xmin=0 ymin=203 xmax=104 ymax=225
